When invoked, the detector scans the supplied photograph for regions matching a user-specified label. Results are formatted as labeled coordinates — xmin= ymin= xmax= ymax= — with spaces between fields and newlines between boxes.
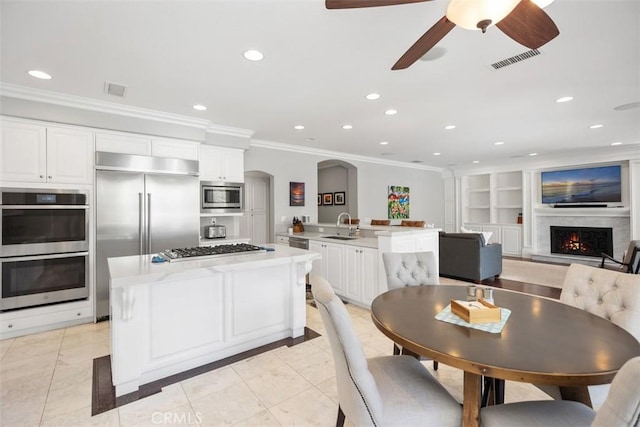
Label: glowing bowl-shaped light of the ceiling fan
xmin=446 ymin=0 xmax=520 ymax=30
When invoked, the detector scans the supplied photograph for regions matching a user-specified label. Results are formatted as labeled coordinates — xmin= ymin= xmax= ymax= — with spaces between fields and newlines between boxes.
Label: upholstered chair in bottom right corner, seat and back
xmin=480 ymin=356 xmax=640 ymax=427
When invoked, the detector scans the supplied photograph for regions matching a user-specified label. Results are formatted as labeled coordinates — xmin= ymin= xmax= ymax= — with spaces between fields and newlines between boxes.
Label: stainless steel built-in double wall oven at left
xmin=0 ymin=188 xmax=89 ymax=310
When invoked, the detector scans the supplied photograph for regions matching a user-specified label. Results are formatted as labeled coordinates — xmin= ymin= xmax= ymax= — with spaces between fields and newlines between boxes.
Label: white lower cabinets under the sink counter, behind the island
xmin=309 ymin=240 xmax=378 ymax=307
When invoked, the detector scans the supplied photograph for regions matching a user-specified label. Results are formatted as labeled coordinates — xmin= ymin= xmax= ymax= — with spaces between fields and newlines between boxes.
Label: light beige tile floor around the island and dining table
xmin=0 ymin=298 xmax=547 ymax=427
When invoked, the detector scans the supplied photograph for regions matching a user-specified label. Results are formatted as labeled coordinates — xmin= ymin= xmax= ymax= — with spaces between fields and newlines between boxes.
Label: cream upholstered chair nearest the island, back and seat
xmin=311 ymin=276 xmax=462 ymax=427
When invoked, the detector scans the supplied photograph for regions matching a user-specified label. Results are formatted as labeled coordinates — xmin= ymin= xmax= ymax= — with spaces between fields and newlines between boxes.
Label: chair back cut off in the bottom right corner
xmin=591 ymin=356 xmax=640 ymax=427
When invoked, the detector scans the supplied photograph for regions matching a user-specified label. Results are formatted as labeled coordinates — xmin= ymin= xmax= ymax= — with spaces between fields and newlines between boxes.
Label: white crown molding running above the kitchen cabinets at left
xmin=0 ymin=83 xmax=254 ymax=138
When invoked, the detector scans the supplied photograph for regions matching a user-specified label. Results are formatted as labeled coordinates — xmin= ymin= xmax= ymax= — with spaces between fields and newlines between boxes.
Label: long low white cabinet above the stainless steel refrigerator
xmin=96 ymin=133 xmax=200 ymax=160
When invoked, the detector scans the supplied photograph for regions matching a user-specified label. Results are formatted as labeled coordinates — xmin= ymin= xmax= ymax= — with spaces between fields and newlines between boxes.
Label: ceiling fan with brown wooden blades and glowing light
xmin=325 ymin=0 xmax=560 ymax=70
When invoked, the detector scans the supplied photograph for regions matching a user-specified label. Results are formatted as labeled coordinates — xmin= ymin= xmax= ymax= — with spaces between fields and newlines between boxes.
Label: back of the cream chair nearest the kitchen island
xmin=310 ymin=276 xmax=383 ymax=426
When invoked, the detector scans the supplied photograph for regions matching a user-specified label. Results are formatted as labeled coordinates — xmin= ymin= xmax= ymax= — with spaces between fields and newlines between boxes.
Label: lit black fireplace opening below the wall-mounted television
xmin=550 ymin=225 xmax=613 ymax=257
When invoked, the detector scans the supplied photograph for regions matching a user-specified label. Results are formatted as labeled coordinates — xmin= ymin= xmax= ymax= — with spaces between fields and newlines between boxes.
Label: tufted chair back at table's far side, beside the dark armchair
xmin=382 ymin=252 xmax=440 ymax=290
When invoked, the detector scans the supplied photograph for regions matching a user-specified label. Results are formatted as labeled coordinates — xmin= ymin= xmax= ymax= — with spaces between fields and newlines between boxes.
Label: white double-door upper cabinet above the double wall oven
xmin=0 ymin=119 xmax=93 ymax=184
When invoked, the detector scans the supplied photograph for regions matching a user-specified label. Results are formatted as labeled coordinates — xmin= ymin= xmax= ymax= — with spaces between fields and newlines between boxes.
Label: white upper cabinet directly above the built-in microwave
xmin=200 ymin=145 xmax=244 ymax=182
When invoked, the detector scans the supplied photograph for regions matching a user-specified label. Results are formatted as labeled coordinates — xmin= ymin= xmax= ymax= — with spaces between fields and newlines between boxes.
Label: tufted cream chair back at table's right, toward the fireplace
xmin=560 ymin=264 xmax=640 ymax=341
